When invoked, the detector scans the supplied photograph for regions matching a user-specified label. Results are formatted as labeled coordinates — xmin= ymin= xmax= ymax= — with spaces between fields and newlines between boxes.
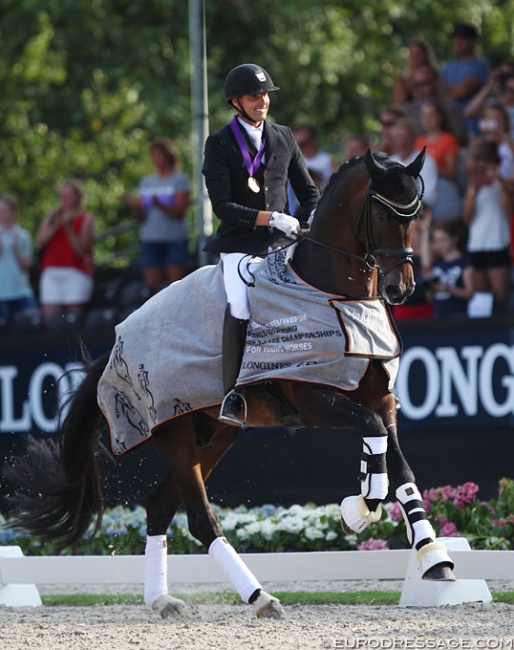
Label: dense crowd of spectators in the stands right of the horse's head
xmin=300 ymin=23 xmax=514 ymax=320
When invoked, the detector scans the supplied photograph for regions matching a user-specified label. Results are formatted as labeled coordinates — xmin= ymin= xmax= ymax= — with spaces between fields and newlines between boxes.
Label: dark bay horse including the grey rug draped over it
xmin=5 ymin=151 xmax=454 ymax=617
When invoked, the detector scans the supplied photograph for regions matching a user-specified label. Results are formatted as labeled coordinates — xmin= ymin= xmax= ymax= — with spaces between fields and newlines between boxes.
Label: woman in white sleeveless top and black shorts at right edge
xmin=462 ymin=139 xmax=512 ymax=316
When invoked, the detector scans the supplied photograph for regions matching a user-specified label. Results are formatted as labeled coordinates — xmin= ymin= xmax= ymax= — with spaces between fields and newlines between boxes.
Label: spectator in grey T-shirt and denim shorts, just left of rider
xmin=121 ymin=137 xmax=191 ymax=294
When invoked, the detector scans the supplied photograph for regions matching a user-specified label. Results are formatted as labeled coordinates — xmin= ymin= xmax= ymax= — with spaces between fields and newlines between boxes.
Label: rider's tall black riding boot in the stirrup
xmin=219 ymin=305 xmax=248 ymax=426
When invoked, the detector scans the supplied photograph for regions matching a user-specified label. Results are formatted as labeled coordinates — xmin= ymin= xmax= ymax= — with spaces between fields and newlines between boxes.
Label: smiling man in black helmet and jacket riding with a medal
xmin=202 ymin=63 xmax=319 ymax=425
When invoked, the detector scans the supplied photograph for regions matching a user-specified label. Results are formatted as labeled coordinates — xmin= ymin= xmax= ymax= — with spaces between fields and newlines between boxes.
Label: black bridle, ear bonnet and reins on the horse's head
xmin=298 ymin=176 xmax=425 ymax=293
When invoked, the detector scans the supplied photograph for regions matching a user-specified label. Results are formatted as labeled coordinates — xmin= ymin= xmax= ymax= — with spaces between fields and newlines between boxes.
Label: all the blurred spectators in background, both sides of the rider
xmin=0 ymin=24 xmax=514 ymax=328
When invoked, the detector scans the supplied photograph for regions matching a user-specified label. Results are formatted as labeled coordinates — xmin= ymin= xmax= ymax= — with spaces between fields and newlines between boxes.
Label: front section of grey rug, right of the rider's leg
xmin=238 ymin=248 xmax=401 ymax=390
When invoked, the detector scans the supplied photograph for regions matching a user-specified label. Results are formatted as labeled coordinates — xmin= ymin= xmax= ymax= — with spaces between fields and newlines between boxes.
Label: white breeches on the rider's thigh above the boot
xmin=220 ymin=253 xmax=263 ymax=320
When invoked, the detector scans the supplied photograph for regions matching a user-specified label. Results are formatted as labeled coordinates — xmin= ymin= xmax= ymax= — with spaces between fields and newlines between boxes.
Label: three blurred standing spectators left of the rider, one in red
xmin=0 ymin=137 xmax=190 ymax=331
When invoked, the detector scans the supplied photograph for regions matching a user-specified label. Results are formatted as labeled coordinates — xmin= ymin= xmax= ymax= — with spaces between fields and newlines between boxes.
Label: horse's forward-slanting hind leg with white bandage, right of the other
xmin=148 ymin=417 xmax=283 ymax=618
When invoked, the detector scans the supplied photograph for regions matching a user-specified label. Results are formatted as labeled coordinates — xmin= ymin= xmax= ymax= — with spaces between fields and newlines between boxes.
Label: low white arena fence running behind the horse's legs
xmin=0 ymin=538 xmax=514 ymax=605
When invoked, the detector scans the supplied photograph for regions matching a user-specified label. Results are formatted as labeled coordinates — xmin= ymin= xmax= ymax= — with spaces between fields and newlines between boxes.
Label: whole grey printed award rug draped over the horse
xmin=98 ymin=252 xmax=401 ymax=454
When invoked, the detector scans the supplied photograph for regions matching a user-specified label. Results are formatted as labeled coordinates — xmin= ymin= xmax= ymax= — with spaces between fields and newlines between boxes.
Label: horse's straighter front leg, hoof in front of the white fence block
xmin=384 ymin=415 xmax=455 ymax=580
